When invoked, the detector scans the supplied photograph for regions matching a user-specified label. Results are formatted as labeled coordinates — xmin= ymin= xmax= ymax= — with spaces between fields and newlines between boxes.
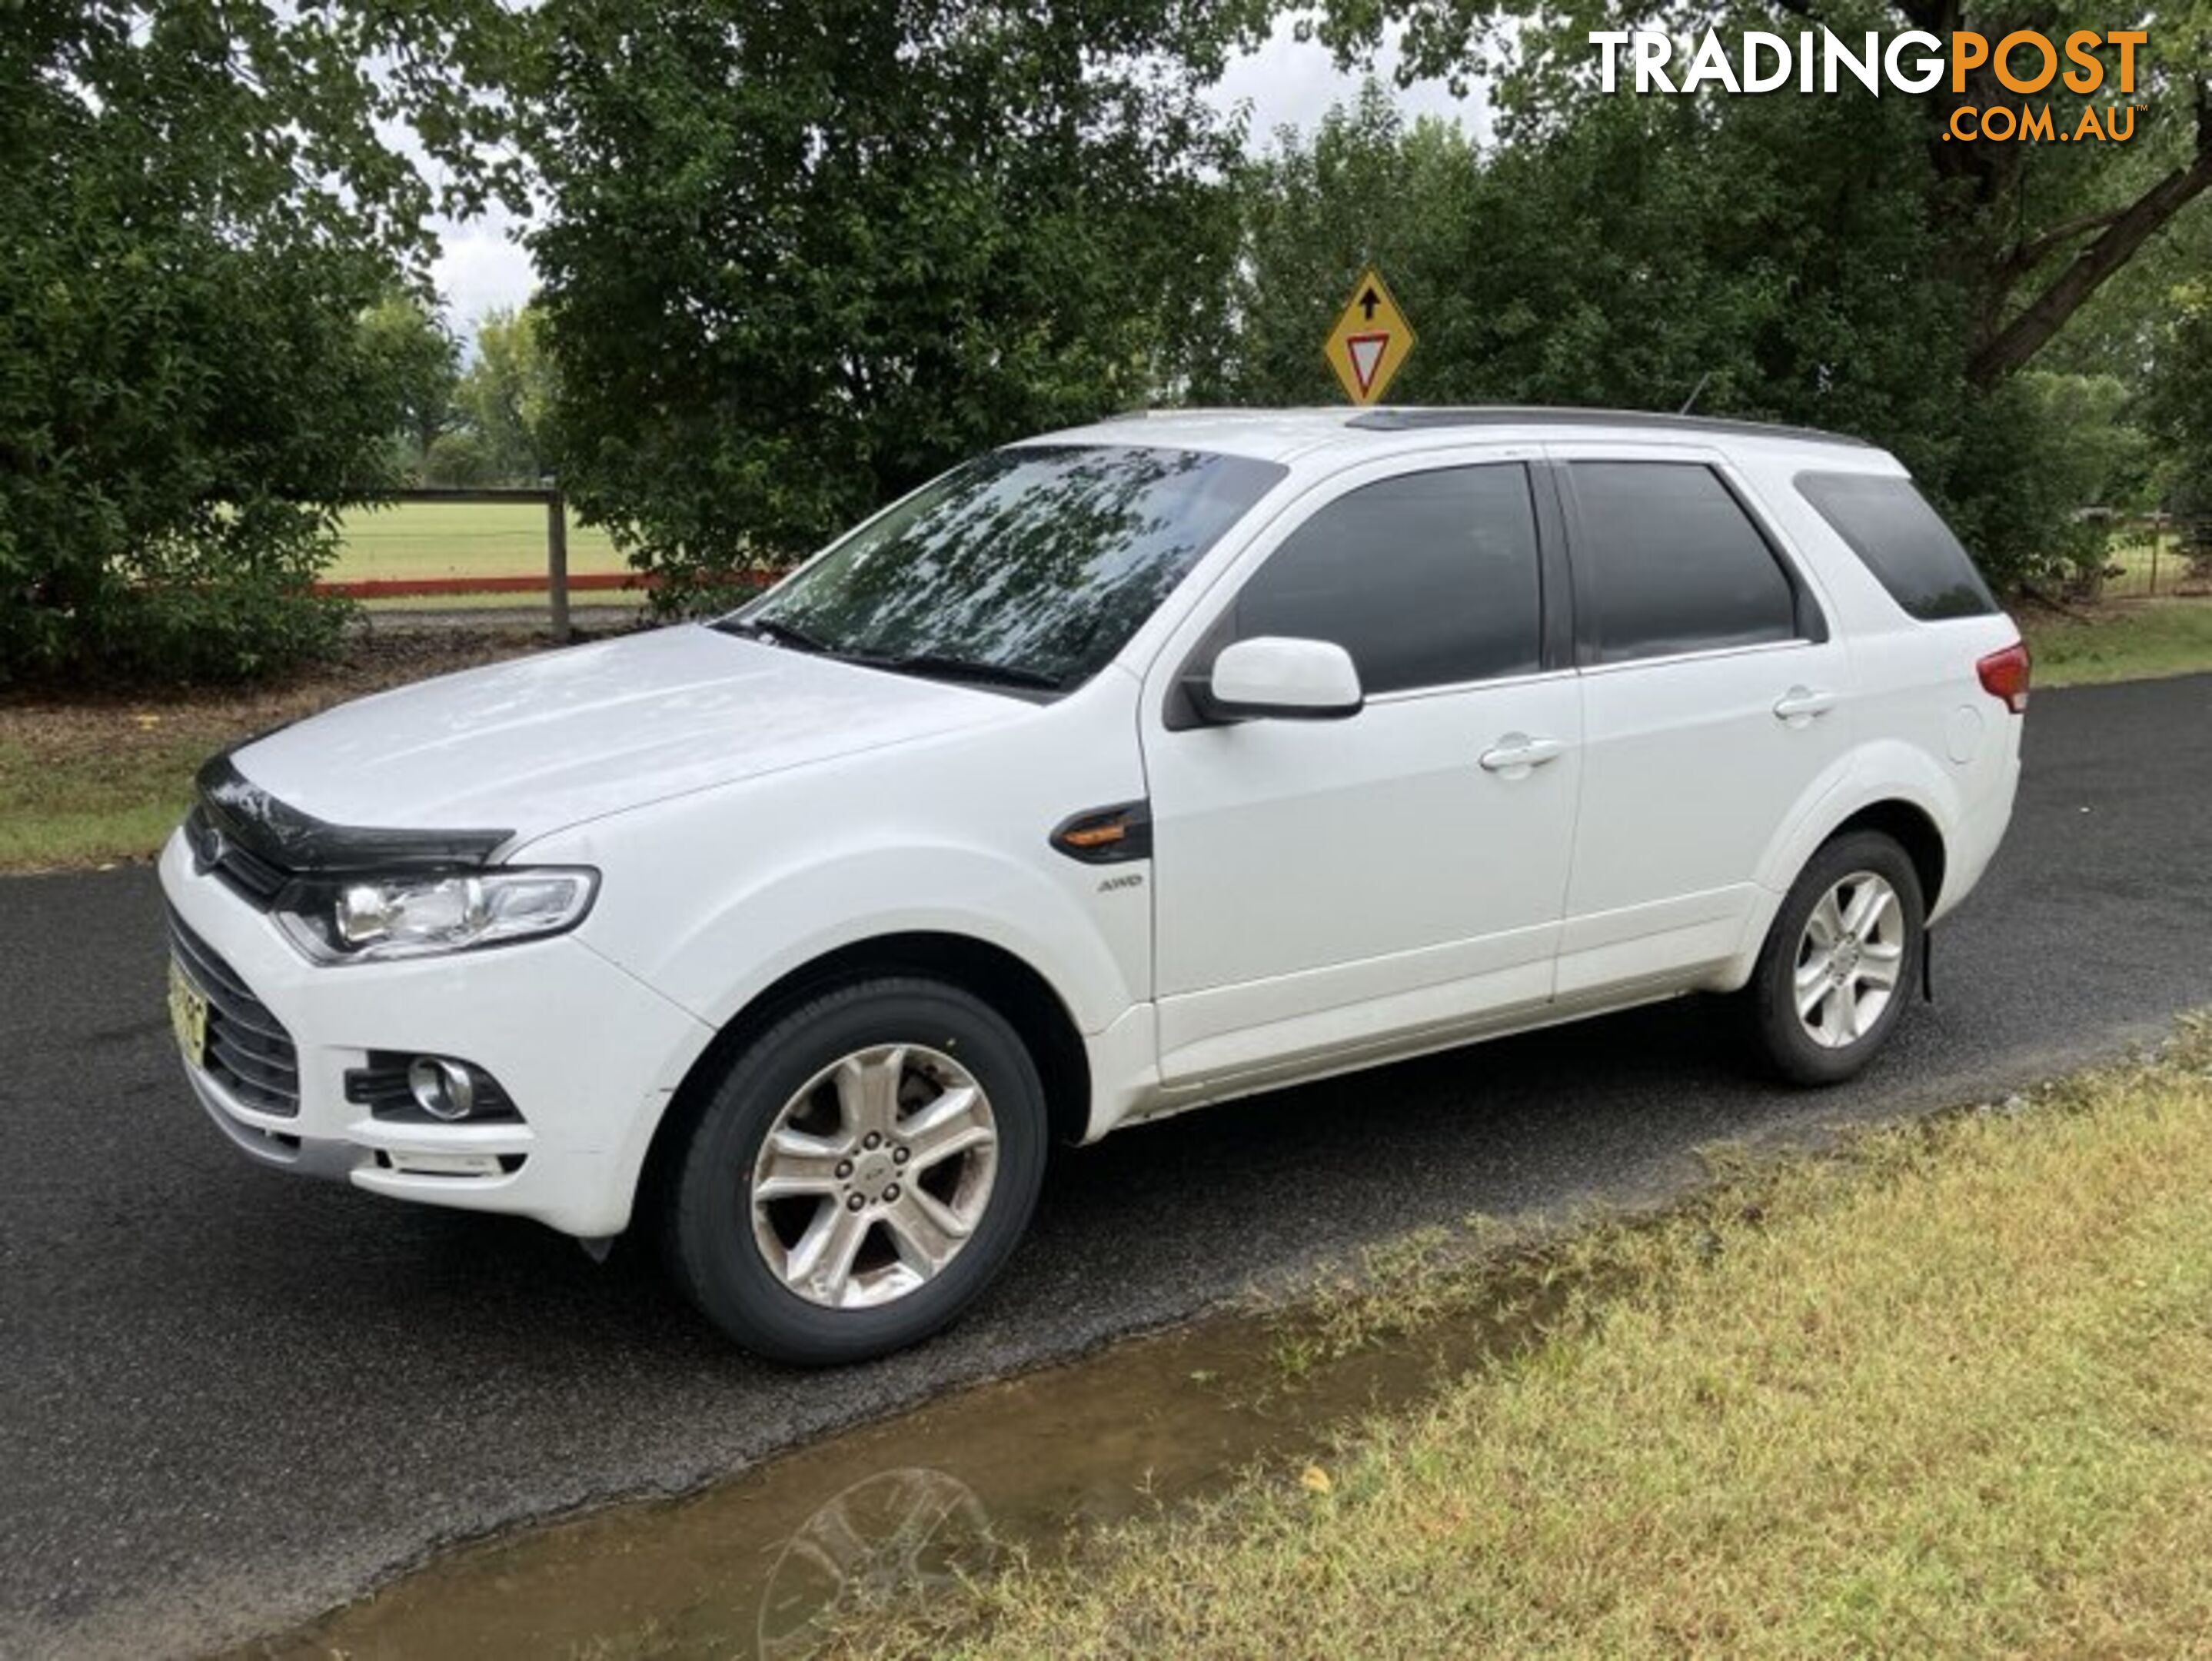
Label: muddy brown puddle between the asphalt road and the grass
xmin=235 ymin=1274 xmax=1559 ymax=1661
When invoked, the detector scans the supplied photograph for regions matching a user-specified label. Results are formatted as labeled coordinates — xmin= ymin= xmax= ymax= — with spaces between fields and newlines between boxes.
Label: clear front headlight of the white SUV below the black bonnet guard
xmin=277 ymin=867 xmax=600 ymax=962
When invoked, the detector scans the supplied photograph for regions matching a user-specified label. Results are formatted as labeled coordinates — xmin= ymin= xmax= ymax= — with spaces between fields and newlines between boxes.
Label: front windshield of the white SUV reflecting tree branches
xmin=717 ymin=444 xmax=1286 ymax=690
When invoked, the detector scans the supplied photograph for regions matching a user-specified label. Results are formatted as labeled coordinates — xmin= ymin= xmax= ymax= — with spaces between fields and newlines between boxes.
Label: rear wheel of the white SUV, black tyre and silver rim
xmin=1743 ymin=831 xmax=1927 ymax=1083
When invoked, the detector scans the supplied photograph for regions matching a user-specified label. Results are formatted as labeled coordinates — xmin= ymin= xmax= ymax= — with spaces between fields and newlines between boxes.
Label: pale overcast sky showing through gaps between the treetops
xmin=434 ymin=20 xmax=1480 ymax=336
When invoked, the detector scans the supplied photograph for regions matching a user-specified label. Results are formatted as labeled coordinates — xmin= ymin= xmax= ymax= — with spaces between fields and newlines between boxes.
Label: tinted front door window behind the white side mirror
xmin=1236 ymin=464 xmax=1542 ymax=692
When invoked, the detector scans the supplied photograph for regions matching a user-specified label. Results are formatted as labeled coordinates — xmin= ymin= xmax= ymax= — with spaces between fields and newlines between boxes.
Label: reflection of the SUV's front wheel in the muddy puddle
xmin=757 ymin=1469 xmax=998 ymax=1661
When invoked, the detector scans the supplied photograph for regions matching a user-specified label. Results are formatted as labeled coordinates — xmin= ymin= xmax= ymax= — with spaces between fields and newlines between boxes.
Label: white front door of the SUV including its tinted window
xmin=1143 ymin=449 xmax=1582 ymax=1088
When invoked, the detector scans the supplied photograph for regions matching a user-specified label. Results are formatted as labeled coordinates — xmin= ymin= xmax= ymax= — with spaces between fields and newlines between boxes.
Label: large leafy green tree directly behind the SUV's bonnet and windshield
xmin=531 ymin=0 xmax=1263 ymax=604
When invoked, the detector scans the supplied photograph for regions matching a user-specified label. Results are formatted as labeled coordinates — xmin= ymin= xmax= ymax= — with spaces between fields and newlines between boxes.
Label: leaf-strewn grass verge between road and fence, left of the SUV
xmin=0 ymin=631 xmax=548 ymax=871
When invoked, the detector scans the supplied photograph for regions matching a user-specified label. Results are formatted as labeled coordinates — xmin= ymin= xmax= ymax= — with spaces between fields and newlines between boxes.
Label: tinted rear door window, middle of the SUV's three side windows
xmin=1571 ymin=462 xmax=1798 ymax=664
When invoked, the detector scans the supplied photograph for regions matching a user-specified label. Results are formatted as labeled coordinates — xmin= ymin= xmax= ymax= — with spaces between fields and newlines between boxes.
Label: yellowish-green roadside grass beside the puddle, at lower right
xmin=850 ymin=1027 xmax=2212 ymax=1661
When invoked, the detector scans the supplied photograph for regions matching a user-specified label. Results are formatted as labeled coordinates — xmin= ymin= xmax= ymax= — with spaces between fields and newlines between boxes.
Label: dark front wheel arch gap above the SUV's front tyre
xmin=633 ymin=929 xmax=1090 ymax=1223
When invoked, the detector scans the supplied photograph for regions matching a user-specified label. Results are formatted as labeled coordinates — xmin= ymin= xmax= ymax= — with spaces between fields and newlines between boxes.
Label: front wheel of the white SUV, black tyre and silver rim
xmin=664 ymin=977 xmax=1046 ymax=1366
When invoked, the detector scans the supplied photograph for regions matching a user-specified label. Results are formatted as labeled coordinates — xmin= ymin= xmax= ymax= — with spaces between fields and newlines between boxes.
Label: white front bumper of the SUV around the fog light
xmin=159 ymin=836 xmax=712 ymax=1239
